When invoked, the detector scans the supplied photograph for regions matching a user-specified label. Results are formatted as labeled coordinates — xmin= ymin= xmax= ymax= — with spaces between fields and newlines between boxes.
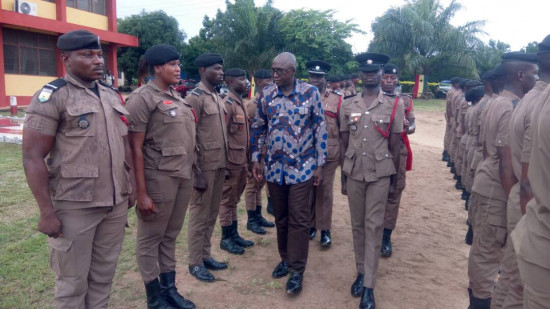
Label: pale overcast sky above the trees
xmin=117 ymin=0 xmax=550 ymax=53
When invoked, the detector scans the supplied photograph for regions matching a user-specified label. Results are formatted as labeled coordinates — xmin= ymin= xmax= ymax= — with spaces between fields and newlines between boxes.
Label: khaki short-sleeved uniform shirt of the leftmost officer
xmin=25 ymin=75 xmax=131 ymax=209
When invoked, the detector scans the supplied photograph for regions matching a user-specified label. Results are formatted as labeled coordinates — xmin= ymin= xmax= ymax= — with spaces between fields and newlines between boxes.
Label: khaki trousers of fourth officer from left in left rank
xmin=220 ymin=165 xmax=248 ymax=226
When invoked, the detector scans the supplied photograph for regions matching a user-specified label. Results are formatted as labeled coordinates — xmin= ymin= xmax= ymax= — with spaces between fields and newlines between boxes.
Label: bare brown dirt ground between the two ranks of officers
xmin=113 ymin=112 xmax=469 ymax=309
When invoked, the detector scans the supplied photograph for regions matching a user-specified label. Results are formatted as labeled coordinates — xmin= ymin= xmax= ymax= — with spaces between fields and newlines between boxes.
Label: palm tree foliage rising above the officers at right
xmin=369 ymin=0 xmax=484 ymax=81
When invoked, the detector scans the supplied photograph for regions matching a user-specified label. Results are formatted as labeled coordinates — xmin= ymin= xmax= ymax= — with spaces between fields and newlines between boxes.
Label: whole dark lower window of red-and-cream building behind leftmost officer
xmin=2 ymin=28 xmax=57 ymax=76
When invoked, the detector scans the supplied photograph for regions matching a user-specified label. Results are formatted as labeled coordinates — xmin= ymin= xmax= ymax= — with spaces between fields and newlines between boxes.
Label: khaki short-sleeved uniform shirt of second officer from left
xmin=127 ymin=81 xmax=195 ymax=179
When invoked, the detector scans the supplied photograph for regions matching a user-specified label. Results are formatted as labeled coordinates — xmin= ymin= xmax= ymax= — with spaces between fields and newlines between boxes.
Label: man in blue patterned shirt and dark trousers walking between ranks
xmin=251 ymin=53 xmax=327 ymax=294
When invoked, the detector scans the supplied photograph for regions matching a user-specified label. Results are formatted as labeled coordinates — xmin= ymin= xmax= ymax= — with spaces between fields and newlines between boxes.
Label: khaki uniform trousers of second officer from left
xmin=136 ymin=169 xmax=193 ymax=282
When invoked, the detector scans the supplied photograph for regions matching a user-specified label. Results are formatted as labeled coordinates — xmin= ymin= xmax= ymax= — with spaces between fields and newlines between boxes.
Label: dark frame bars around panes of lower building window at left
xmin=2 ymin=28 xmax=58 ymax=76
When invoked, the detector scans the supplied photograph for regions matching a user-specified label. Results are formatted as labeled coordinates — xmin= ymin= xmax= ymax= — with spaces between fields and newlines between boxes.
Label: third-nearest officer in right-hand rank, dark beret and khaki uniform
xmin=468 ymin=53 xmax=537 ymax=308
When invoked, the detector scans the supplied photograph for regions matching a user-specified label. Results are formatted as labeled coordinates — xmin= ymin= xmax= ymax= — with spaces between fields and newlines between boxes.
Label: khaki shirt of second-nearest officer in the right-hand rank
xmin=510 ymin=81 xmax=548 ymax=179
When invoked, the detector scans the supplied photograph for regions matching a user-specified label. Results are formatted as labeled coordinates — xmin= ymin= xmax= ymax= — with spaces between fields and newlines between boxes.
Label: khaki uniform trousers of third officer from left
xmin=187 ymin=167 xmax=225 ymax=266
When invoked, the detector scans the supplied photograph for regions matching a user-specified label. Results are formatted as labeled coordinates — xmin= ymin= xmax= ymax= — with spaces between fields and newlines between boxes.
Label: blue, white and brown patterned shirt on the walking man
xmin=251 ymin=79 xmax=327 ymax=185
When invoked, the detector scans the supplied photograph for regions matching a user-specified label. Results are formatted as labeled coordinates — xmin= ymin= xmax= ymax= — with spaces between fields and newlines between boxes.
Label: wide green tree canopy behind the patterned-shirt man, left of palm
xmin=182 ymin=0 xmax=362 ymax=76
